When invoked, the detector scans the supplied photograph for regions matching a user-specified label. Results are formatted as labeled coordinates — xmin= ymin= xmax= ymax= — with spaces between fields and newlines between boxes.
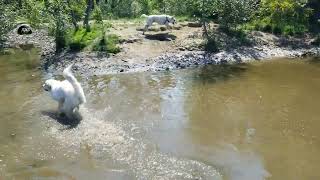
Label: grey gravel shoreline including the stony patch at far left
xmin=5 ymin=26 xmax=320 ymax=77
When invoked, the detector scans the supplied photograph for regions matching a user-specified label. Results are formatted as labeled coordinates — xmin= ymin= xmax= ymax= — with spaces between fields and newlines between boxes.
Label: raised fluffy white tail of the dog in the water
xmin=63 ymin=65 xmax=86 ymax=104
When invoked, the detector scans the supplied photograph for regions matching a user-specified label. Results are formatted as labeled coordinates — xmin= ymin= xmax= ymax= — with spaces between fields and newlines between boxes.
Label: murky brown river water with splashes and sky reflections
xmin=0 ymin=51 xmax=320 ymax=180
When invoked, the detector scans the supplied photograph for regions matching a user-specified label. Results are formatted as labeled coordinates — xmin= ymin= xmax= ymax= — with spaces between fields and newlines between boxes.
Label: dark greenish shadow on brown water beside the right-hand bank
xmin=193 ymin=63 xmax=250 ymax=83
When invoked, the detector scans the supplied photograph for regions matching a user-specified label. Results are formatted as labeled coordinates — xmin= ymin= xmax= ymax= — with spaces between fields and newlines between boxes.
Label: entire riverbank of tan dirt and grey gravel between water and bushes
xmin=3 ymin=22 xmax=320 ymax=76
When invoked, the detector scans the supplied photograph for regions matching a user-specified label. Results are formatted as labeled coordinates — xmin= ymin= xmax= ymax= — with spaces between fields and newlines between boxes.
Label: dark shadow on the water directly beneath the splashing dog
xmin=41 ymin=111 xmax=82 ymax=129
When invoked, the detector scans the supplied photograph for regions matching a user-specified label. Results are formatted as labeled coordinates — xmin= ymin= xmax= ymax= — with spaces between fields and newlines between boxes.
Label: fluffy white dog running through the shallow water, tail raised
xmin=43 ymin=65 xmax=86 ymax=118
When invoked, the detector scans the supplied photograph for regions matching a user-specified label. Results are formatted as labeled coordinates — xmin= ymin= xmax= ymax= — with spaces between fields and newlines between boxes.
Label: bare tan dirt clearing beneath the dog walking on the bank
xmin=109 ymin=22 xmax=202 ymax=63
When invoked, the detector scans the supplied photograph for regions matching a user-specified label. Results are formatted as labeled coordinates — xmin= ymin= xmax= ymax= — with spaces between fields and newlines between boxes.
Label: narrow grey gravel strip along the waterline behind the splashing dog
xmin=47 ymin=46 xmax=320 ymax=76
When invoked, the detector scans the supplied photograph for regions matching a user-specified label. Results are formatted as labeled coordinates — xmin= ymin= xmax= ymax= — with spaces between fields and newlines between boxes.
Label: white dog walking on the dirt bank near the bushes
xmin=141 ymin=14 xmax=177 ymax=34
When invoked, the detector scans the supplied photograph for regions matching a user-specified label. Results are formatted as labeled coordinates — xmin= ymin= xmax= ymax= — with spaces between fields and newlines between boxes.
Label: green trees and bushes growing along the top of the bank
xmin=0 ymin=0 xmax=320 ymax=52
